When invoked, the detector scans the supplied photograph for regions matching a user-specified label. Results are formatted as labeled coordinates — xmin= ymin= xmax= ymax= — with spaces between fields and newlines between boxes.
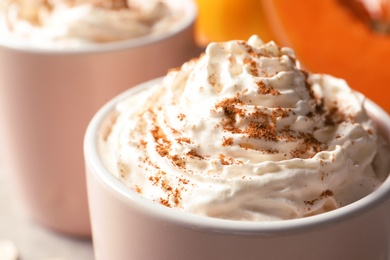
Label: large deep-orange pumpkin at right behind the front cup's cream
xmin=262 ymin=0 xmax=390 ymax=112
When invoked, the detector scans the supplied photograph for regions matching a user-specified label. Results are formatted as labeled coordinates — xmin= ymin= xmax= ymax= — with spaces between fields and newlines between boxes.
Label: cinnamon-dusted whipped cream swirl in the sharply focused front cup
xmin=101 ymin=36 xmax=390 ymax=221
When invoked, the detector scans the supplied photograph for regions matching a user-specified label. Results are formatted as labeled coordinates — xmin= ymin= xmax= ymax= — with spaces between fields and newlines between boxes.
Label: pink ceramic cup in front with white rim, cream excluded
xmin=84 ymin=81 xmax=390 ymax=260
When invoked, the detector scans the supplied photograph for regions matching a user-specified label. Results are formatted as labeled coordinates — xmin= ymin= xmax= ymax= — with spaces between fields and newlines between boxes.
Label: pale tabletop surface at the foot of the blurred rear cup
xmin=0 ymin=165 xmax=94 ymax=260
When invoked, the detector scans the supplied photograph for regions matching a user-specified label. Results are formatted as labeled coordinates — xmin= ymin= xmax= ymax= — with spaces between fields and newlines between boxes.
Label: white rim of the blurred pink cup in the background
xmin=0 ymin=0 xmax=198 ymax=55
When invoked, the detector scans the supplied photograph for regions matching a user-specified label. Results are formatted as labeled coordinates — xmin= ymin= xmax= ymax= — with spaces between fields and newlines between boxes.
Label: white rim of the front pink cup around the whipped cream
xmin=84 ymin=77 xmax=390 ymax=236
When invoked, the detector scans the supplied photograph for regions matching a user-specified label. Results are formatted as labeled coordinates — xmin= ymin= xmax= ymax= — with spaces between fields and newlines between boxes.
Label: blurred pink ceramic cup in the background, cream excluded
xmin=0 ymin=0 xmax=197 ymax=236
